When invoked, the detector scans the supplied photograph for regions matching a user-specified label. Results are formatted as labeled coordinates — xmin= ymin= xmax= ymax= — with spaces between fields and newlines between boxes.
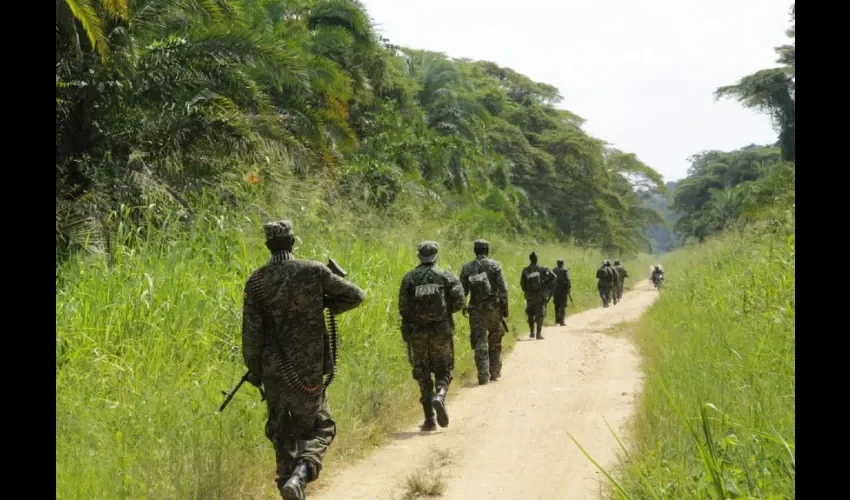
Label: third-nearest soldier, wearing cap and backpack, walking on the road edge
xmin=460 ymin=240 xmax=508 ymax=385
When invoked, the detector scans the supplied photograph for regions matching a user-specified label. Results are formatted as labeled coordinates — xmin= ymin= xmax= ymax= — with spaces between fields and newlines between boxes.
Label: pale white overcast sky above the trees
xmin=362 ymin=0 xmax=793 ymax=182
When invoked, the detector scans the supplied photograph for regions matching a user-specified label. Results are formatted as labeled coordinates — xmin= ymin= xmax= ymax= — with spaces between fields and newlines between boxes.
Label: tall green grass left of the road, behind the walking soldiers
xmin=56 ymin=193 xmax=643 ymax=500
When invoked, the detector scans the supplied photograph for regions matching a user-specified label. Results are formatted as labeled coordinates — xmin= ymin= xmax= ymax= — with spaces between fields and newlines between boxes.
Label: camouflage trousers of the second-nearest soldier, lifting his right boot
xmin=407 ymin=328 xmax=454 ymax=404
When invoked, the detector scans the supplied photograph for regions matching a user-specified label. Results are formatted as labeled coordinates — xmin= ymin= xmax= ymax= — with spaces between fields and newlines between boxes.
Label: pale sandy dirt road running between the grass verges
xmin=308 ymin=280 xmax=657 ymax=500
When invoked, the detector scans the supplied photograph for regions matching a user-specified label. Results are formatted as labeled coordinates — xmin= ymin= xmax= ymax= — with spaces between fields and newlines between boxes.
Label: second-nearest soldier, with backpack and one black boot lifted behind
xmin=398 ymin=241 xmax=464 ymax=431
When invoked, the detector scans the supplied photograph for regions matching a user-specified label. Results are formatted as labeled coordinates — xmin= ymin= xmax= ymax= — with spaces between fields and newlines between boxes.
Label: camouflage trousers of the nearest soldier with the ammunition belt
xmin=263 ymin=379 xmax=336 ymax=488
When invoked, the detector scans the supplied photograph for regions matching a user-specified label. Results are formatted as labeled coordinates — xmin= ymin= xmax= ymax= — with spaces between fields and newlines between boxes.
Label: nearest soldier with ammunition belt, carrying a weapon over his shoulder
xmin=242 ymin=220 xmax=365 ymax=500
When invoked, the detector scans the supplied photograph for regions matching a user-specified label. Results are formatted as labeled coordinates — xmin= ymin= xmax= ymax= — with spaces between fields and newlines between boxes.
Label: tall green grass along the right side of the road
xmin=600 ymin=213 xmax=795 ymax=500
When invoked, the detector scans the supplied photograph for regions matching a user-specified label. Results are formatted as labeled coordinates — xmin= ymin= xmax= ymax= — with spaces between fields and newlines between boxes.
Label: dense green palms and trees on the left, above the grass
xmin=56 ymin=0 xmax=666 ymax=255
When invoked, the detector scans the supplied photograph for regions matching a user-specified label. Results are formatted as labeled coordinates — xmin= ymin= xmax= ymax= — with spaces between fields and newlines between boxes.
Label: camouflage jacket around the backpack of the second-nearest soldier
xmin=398 ymin=264 xmax=464 ymax=330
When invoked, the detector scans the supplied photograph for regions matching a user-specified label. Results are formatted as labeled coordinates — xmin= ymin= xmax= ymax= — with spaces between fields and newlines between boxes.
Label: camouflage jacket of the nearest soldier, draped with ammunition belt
xmin=242 ymin=259 xmax=366 ymax=386
